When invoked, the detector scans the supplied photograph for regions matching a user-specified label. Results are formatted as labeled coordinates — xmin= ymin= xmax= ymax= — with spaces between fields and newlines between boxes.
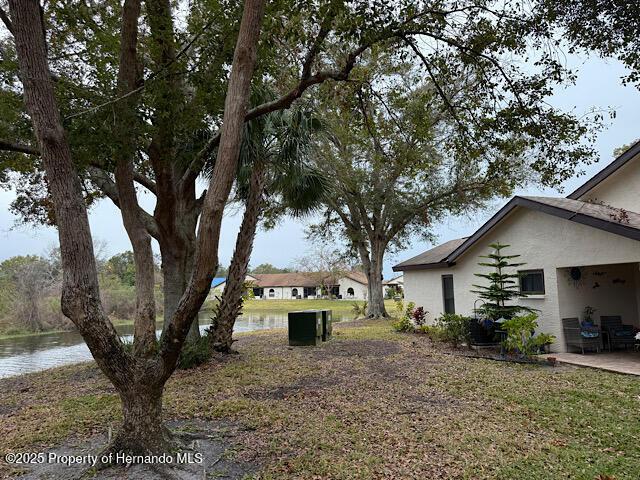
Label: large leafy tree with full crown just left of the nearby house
xmin=311 ymin=54 xmax=590 ymax=317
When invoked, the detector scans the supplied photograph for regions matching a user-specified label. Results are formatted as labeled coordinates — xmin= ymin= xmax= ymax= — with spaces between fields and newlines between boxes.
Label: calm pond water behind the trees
xmin=0 ymin=312 xmax=342 ymax=378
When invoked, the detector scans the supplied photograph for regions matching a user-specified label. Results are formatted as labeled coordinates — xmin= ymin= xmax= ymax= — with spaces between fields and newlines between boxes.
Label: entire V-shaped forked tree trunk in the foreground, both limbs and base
xmin=9 ymin=0 xmax=265 ymax=453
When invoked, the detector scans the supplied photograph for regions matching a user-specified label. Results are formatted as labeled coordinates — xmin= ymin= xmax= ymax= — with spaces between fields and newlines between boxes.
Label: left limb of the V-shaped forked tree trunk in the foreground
xmin=9 ymin=0 xmax=130 ymax=383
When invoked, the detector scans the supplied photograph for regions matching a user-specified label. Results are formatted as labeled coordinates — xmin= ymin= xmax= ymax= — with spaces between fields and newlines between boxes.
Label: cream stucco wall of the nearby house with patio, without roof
xmin=404 ymin=207 xmax=640 ymax=351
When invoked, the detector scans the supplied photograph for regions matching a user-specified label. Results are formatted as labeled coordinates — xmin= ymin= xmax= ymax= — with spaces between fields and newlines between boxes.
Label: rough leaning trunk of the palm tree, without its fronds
xmin=209 ymin=162 xmax=265 ymax=353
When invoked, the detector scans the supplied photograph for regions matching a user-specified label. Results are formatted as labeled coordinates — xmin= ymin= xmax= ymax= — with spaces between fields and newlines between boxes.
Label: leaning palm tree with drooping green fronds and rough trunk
xmin=208 ymin=105 xmax=327 ymax=353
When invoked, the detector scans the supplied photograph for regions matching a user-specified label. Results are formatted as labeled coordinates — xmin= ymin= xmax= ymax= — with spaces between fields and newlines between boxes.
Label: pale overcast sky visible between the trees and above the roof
xmin=0 ymin=52 xmax=640 ymax=276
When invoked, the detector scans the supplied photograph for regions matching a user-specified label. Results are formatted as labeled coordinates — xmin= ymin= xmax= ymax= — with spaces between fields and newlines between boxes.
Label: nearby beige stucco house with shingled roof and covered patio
xmin=394 ymin=142 xmax=640 ymax=351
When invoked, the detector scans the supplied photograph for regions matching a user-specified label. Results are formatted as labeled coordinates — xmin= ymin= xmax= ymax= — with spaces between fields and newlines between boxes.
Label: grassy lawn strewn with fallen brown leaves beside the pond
xmin=0 ymin=318 xmax=640 ymax=480
